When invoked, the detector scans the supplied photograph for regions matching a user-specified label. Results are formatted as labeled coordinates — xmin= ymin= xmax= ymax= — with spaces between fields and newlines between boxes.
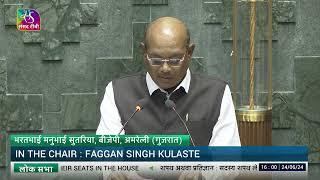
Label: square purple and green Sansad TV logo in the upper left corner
xmin=17 ymin=9 xmax=41 ymax=31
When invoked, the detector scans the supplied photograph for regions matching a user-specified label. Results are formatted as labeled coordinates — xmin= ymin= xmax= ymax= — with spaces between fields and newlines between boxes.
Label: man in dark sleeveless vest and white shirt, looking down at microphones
xmin=97 ymin=17 xmax=240 ymax=179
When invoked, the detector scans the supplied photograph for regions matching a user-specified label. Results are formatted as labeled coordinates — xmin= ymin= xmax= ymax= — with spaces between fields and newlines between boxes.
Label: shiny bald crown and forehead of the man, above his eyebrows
xmin=144 ymin=17 xmax=190 ymax=48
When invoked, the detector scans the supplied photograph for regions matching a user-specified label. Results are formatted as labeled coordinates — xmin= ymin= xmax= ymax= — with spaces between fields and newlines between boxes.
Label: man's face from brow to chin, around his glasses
xmin=144 ymin=40 xmax=194 ymax=89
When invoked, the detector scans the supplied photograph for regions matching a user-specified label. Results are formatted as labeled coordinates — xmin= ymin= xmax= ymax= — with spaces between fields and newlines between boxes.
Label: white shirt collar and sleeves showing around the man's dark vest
xmin=96 ymin=69 xmax=241 ymax=146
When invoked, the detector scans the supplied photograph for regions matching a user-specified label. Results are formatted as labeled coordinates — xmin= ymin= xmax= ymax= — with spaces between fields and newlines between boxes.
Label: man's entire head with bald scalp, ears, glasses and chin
xmin=141 ymin=17 xmax=195 ymax=92
